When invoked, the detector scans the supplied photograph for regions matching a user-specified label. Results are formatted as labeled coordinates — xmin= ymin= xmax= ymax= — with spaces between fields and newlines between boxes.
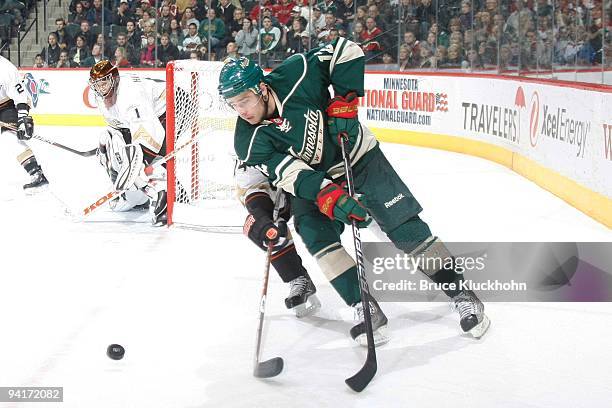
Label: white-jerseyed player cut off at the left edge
xmin=0 ymin=55 xmax=48 ymax=190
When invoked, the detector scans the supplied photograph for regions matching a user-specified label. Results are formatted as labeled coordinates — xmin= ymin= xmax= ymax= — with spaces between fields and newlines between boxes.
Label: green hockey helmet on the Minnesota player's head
xmin=218 ymin=57 xmax=263 ymax=99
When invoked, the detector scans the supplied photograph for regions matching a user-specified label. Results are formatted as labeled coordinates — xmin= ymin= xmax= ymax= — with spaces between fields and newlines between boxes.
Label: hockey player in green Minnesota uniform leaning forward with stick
xmin=219 ymin=37 xmax=489 ymax=344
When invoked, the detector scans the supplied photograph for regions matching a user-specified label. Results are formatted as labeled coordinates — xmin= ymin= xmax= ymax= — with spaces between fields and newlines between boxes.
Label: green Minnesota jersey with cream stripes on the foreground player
xmin=234 ymin=37 xmax=377 ymax=200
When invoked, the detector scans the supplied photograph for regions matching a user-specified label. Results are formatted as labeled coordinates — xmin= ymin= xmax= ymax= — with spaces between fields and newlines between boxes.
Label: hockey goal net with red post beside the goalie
xmin=166 ymin=60 xmax=244 ymax=232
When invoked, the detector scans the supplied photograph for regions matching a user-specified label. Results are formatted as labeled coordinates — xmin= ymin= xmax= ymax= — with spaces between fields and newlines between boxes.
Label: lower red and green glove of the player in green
xmin=317 ymin=183 xmax=372 ymax=228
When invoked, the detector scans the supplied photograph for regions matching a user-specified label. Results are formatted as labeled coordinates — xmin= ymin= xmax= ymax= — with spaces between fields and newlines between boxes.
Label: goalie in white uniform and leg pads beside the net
xmin=89 ymin=60 xmax=167 ymax=225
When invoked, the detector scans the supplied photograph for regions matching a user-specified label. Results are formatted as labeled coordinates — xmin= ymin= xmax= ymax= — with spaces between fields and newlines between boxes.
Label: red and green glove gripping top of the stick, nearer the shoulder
xmin=326 ymin=92 xmax=359 ymax=146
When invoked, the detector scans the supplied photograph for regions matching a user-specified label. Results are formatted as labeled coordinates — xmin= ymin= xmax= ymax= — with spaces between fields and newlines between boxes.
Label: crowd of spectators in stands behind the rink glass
xmin=29 ymin=0 xmax=612 ymax=70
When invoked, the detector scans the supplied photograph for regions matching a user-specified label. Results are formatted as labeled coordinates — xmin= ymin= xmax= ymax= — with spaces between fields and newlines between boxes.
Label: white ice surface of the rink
xmin=0 ymin=127 xmax=612 ymax=408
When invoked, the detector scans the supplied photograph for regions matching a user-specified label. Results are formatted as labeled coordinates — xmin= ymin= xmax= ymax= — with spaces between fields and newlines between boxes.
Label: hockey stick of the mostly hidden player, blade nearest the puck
xmin=253 ymin=190 xmax=284 ymax=378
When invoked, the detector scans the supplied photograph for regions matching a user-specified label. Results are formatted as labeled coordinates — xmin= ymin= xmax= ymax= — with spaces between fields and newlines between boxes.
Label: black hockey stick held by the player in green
xmin=338 ymin=133 xmax=378 ymax=392
